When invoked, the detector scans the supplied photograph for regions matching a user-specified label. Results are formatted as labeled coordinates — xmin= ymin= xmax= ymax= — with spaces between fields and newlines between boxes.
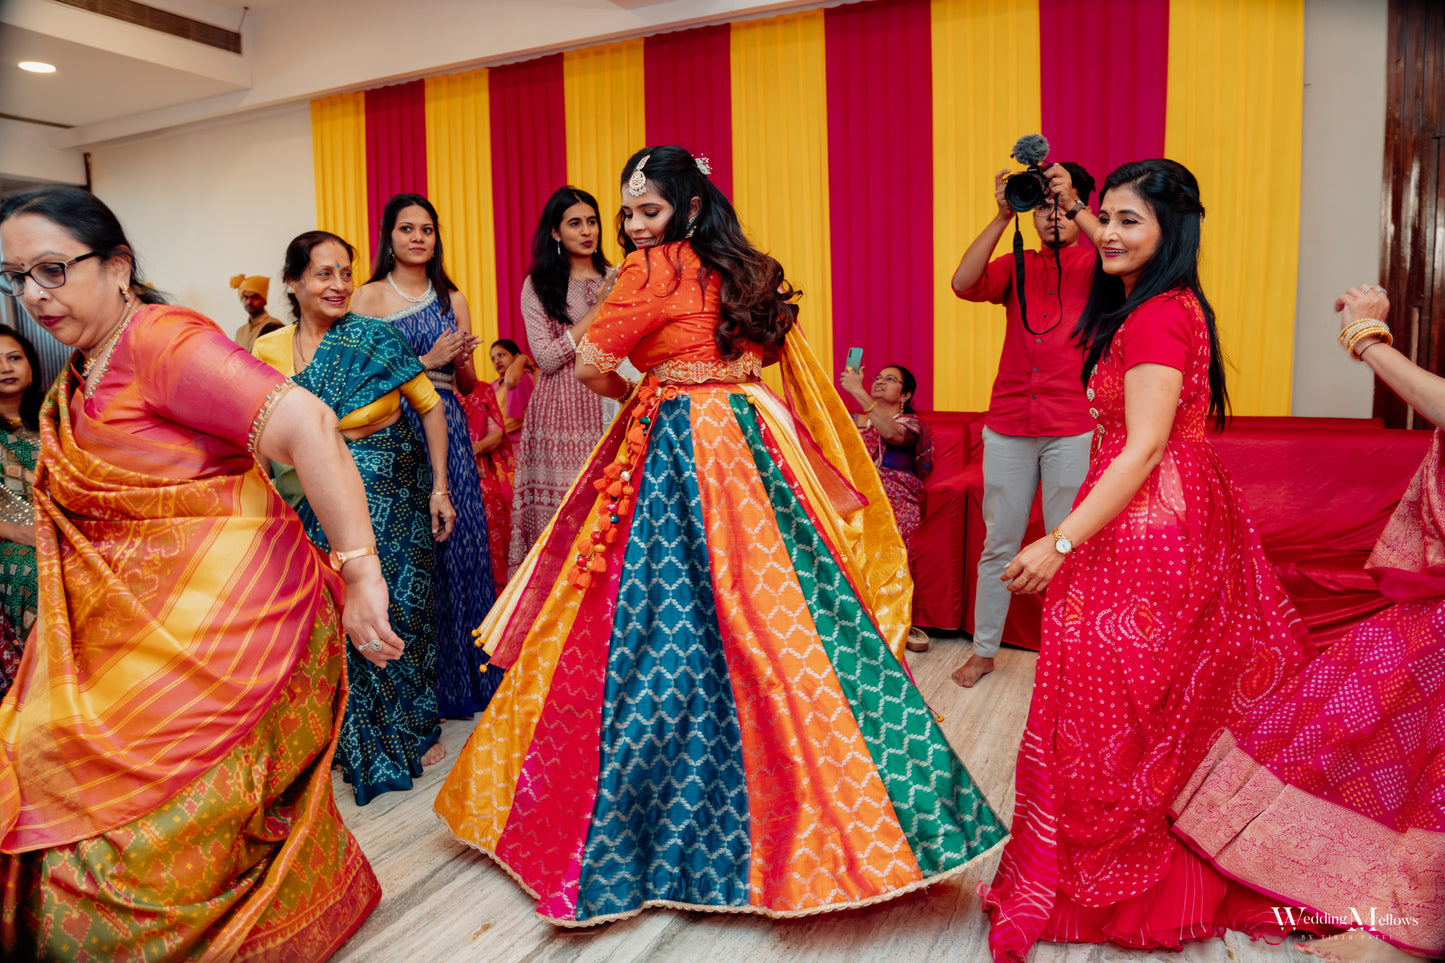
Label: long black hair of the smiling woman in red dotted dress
xmin=1074 ymin=158 xmax=1230 ymax=429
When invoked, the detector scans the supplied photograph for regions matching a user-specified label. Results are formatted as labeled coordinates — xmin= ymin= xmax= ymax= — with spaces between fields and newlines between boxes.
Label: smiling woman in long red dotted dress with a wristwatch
xmin=983 ymin=161 xmax=1309 ymax=960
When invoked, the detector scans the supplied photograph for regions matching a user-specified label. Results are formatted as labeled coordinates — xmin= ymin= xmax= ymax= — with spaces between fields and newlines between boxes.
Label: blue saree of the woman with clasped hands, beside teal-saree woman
xmin=358 ymin=292 xmax=501 ymax=719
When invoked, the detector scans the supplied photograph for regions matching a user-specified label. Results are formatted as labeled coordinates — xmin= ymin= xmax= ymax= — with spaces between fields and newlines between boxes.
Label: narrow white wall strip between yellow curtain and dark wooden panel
xmin=1290 ymin=0 xmax=1389 ymax=418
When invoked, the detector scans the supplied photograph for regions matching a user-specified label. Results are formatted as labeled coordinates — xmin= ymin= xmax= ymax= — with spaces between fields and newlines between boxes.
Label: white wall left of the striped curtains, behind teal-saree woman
xmin=91 ymin=103 xmax=316 ymax=333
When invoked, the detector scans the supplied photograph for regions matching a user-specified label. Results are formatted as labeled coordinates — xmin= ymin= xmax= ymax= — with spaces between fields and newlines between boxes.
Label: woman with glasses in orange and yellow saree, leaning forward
xmin=0 ymin=187 xmax=402 ymax=960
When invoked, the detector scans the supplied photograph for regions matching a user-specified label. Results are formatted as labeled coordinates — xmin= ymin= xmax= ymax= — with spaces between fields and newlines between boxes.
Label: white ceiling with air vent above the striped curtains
xmin=0 ymin=0 xmax=826 ymax=151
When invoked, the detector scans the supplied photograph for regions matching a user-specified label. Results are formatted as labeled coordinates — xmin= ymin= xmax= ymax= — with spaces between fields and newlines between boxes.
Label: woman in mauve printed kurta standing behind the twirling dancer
xmin=507 ymin=187 xmax=607 ymax=575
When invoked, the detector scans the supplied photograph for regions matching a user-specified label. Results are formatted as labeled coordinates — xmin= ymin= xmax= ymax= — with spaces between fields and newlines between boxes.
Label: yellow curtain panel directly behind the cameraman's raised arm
xmin=932 ymin=0 xmax=1042 ymax=411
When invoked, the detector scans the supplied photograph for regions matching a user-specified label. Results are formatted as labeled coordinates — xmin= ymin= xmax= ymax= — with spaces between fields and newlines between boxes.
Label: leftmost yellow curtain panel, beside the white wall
xmin=311 ymin=91 xmax=371 ymax=273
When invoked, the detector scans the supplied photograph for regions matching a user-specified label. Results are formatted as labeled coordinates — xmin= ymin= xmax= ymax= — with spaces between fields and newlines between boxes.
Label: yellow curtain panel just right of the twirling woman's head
xmin=733 ymin=10 xmax=832 ymax=370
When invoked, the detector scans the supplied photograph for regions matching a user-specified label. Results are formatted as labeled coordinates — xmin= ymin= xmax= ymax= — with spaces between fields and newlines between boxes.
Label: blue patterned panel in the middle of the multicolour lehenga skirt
xmin=577 ymin=396 xmax=751 ymax=920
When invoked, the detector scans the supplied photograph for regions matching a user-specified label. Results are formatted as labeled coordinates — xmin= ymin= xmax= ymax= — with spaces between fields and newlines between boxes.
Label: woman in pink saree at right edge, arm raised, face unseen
xmin=1173 ymin=285 xmax=1445 ymax=960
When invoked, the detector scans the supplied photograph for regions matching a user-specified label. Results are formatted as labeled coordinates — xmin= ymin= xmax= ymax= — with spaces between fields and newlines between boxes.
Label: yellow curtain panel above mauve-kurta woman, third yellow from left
xmin=562 ymin=39 xmax=647 ymax=265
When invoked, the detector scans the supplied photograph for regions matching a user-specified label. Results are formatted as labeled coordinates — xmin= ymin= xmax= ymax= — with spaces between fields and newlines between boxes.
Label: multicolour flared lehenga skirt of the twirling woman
xmin=436 ymin=385 xmax=1006 ymax=925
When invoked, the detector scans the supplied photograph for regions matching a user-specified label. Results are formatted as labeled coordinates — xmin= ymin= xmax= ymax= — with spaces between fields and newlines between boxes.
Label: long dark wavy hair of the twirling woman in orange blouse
xmin=617 ymin=145 xmax=802 ymax=360
